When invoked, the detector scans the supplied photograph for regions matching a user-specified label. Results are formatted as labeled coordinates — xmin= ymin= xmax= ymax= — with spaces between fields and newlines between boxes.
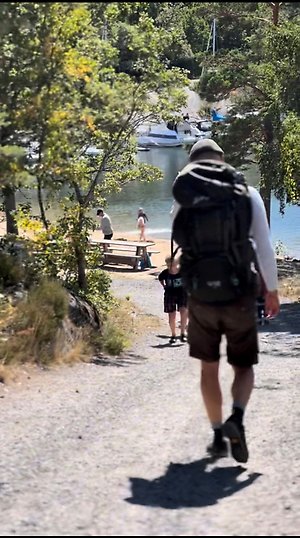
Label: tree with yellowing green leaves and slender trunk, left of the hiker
xmin=0 ymin=2 xmax=186 ymax=290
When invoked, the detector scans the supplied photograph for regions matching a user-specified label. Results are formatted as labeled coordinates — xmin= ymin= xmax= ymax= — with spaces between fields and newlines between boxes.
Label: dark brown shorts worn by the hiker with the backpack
xmin=188 ymin=297 xmax=258 ymax=368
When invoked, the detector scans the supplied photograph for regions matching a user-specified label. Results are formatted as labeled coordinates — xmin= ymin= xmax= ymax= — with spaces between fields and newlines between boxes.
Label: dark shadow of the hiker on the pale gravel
xmin=125 ymin=457 xmax=262 ymax=510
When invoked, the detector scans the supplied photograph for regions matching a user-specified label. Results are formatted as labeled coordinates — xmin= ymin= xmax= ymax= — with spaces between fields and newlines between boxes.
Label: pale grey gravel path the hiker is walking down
xmin=0 ymin=275 xmax=300 ymax=536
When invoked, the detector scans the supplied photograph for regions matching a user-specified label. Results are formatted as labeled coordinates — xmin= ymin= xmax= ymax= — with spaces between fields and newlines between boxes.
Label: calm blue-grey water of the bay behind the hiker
xmin=107 ymin=148 xmax=300 ymax=258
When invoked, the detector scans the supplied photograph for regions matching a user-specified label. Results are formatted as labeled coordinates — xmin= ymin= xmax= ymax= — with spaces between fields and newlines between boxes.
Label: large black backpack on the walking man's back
xmin=172 ymin=161 xmax=256 ymax=304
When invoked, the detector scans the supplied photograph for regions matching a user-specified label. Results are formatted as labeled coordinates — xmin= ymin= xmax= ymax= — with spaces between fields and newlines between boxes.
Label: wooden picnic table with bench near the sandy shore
xmin=90 ymin=239 xmax=155 ymax=269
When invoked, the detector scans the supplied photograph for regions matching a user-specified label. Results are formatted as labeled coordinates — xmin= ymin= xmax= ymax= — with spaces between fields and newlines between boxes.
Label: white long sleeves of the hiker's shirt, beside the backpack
xmin=170 ymin=186 xmax=278 ymax=291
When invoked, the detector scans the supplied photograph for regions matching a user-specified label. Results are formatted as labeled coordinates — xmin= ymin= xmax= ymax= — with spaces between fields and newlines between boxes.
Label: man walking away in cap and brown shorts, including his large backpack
xmin=172 ymin=139 xmax=280 ymax=463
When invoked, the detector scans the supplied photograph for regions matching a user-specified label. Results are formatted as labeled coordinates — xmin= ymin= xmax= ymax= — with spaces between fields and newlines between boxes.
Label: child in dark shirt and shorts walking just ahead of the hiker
xmin=158 ymin=257 xmax=188 ymax=344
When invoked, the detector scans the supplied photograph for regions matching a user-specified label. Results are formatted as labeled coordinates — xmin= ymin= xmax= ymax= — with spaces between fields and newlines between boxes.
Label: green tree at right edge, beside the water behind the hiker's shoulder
xmin=200 ymin=3 xmax=300 ymax=218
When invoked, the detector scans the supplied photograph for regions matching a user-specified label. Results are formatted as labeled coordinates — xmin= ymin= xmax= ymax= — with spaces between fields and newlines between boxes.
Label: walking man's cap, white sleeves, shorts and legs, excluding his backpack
xmin=171 ymin=139 xmax=280 ymax=463
